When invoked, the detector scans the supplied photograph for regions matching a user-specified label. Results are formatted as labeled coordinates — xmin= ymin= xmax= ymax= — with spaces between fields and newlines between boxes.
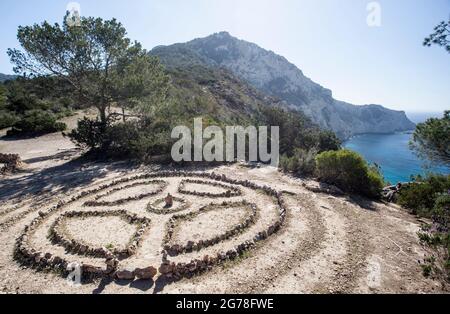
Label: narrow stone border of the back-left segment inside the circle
xmin=84 ymin=180 xmax=168 ymax=207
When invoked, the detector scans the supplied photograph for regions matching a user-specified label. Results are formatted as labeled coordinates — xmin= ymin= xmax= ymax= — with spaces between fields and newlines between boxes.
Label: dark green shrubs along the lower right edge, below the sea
xmin=397 ymin=174 xmax=450 ymax=282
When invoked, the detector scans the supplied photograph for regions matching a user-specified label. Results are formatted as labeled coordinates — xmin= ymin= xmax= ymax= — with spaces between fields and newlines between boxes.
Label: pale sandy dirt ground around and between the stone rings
xmin=0 ymin=128 xmax=447 ymax=294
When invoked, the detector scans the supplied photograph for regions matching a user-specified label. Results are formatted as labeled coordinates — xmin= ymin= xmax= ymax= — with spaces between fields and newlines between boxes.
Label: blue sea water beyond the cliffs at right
xmin=343 ymin=113 xmax=450 ymax=184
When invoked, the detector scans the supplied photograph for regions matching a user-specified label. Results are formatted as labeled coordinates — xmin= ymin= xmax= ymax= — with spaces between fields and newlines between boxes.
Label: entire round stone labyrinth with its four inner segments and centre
xmin=15 ymin=172 xmax=286 ymax=280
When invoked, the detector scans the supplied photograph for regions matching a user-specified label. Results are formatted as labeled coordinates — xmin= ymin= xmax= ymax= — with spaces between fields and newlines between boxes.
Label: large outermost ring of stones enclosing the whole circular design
xmin=14 ymin=171 xmax=287 ymax=280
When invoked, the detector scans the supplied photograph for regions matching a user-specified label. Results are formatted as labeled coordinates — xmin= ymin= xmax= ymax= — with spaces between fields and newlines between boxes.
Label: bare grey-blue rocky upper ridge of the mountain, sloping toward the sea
xmin=152 ymin=32 xmax=415 ymax=139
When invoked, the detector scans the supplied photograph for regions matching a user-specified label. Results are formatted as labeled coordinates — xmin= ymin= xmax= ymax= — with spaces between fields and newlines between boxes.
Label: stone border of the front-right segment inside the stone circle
xmin=163 ymin=200 xmax=258 ymax=257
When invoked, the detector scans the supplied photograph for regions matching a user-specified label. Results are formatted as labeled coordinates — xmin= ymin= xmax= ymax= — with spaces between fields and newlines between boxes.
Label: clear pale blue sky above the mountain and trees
xmin=0 ymin=0 xmax=450 ymax=112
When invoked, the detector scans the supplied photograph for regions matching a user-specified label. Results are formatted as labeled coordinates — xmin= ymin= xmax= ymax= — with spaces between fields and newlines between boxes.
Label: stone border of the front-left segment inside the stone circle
xmin=48 ymin=210 xmax=151 ymax=259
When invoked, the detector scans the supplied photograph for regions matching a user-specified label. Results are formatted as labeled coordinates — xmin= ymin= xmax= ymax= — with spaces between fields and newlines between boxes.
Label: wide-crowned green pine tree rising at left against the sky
xmin=8 ymin=17 xmax=169 ymax=125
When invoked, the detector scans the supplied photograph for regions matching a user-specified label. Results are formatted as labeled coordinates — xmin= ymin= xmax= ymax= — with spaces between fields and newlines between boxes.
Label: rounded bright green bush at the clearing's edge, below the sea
xmin=316 ymin=150 xmax=384 ymax=198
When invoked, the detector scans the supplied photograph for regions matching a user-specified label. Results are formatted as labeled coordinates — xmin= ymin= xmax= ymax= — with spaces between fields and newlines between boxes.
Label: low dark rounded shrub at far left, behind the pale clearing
xmin=8 ymin=109 xmax=66 ymax=135
